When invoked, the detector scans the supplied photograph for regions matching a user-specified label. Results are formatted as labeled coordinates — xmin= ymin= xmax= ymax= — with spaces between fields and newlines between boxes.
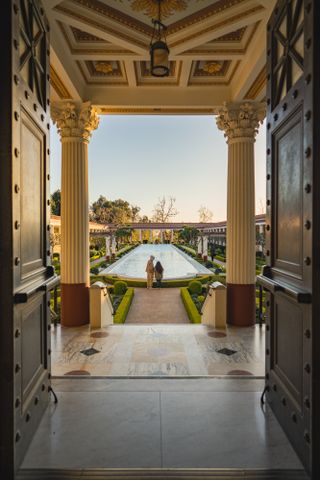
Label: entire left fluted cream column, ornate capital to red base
xmin=51 ymin=101 xmax=99 ymax=326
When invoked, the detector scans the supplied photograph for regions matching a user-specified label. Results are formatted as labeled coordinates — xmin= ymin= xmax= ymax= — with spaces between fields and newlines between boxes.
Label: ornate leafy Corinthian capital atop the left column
xmin=51 ymin=101 xmax=99 ymax=142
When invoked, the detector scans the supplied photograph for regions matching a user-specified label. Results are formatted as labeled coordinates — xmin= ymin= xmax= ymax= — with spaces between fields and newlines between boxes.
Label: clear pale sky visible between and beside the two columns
xmin=51 ymin=115 xmax=266 ymax=222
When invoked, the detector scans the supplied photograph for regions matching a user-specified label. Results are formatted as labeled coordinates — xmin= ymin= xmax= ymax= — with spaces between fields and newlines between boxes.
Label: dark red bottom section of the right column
xmin=227 ymin=283 xmax=256 ymax=327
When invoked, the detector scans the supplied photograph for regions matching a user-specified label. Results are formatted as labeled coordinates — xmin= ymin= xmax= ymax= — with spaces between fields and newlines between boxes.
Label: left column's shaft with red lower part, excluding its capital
xmin=61 ymin=137 xmax=89 ymax=326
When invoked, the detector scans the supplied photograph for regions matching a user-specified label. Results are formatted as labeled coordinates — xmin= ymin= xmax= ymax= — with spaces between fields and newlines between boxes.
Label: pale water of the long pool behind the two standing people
xmin=100 ymin=244 xmax=212 ymax=279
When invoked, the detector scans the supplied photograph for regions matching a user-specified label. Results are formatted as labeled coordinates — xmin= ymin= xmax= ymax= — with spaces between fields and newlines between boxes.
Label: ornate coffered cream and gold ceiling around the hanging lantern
xmin=43 ymin=0 xmax=275 ymax=113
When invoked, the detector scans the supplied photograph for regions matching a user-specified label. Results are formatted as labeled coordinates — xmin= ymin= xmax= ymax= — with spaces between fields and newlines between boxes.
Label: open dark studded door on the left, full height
xmin=0 ymin=0 xmax=53 ymax=479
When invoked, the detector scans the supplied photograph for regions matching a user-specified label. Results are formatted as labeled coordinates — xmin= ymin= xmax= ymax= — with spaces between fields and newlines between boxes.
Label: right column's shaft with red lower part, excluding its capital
xmin=227 ymin=138 xmax=255 ymax=325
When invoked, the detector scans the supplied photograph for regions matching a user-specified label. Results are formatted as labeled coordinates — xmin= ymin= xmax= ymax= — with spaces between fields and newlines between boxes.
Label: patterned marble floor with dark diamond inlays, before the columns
xmin=51 ymin=324 xmax=265 ymax=377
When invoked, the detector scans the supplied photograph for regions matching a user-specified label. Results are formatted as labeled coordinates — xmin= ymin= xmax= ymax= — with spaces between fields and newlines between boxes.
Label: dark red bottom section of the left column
xmin=61 ymin=283 xmax=90 ymax=327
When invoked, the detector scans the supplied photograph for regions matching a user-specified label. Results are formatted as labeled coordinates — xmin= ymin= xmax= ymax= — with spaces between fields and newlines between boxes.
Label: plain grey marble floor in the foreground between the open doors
xmin=18 ymin=378 xmax=305 ymax=479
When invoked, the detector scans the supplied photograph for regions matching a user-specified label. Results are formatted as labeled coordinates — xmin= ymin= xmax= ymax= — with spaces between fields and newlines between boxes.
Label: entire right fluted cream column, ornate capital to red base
xmin=217 ymin=102 xmax=265 ymax=326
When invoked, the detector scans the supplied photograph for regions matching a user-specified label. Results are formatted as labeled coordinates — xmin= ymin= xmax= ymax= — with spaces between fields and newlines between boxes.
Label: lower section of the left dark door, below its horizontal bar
xmin=14 ymin=291 xmax=50 ymax=465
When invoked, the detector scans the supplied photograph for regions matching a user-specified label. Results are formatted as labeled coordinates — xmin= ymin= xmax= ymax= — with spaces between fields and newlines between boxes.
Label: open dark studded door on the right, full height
xmin=261 ymin=0 xmax=320 ymax=478
